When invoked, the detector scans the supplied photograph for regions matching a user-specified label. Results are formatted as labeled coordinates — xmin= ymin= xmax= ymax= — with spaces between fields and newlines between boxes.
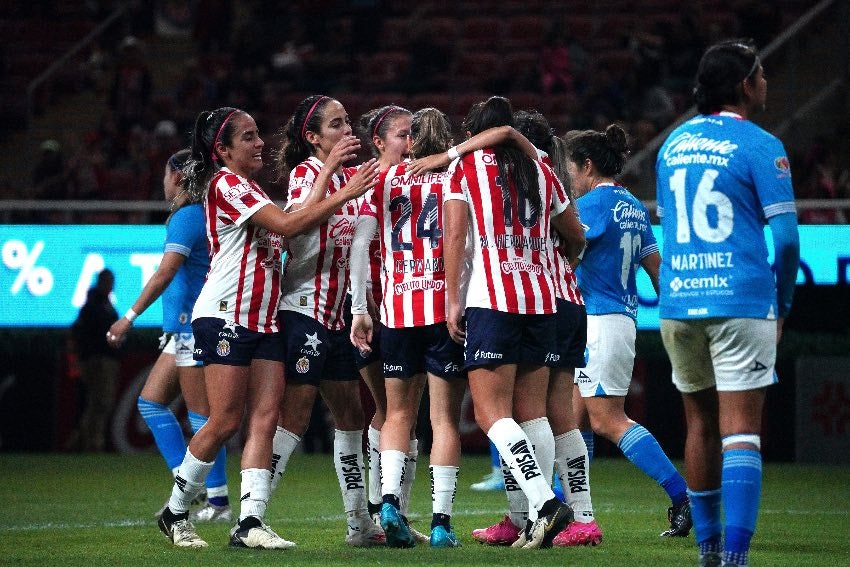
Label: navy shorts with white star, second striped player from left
xmin=277 ymin=311 xmax=360 ymax=386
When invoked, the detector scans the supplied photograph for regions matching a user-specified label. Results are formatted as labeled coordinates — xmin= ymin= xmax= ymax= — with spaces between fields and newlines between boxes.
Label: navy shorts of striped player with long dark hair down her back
xmin=464 ymin=307 xmax=555 ymax=368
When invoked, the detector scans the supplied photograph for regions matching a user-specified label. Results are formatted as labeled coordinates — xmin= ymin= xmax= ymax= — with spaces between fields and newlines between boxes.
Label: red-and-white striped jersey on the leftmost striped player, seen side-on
xmin=192 ymin=168 xmax=283 ymax=333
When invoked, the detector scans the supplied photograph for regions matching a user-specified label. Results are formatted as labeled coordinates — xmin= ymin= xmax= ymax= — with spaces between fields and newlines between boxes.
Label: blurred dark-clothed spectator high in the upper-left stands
xmin=109 ymin=36 xmax=153 ymax=130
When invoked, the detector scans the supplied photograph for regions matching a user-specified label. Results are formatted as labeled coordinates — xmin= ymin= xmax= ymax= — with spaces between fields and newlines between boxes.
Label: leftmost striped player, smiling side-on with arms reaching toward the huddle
xmin=159 ymin=107 xmax=375 ymax=549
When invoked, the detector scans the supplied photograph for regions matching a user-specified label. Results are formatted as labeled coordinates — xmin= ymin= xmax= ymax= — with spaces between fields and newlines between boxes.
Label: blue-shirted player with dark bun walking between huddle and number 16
xmin=567 ymin=124 xmax=691 ymax=536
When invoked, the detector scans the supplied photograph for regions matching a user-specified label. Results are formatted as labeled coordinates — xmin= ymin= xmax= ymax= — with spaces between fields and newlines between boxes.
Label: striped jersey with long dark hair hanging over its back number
xmin=444 ymin=148 xmax=569 ymax=314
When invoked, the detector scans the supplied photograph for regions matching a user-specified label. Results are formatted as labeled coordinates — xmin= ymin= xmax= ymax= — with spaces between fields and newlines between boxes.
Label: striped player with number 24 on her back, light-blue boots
xmin=351 ymin=108 xmax=466 ymax=547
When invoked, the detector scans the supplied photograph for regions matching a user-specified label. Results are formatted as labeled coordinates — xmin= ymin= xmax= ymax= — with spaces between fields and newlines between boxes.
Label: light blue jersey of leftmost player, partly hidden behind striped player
xmin=162 ymin=203 xmax=210 ymax=333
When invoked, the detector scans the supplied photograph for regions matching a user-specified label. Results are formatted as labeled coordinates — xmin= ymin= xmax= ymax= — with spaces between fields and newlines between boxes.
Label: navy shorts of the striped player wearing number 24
xmin=381 ymin=323 xmax=466 ymax=380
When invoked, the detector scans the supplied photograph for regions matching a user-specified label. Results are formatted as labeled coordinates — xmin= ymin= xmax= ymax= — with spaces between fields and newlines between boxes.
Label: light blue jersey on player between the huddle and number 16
xmin=576 ymin=184 xmax=658 ymax=319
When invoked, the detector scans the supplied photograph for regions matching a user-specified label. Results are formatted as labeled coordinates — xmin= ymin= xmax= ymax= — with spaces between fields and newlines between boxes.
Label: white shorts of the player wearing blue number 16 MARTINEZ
xmin=661 ymin=318 xmax=778 ymax=394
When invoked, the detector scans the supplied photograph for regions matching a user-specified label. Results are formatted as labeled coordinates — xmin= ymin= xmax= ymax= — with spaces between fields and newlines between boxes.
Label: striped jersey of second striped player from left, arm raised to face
xmin=280 ymin=156 xmax=368 ymax=330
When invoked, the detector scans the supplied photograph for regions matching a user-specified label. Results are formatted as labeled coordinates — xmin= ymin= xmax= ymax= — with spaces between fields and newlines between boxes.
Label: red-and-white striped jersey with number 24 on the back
xmin=368 ymin=162 xmax=448 ymax=328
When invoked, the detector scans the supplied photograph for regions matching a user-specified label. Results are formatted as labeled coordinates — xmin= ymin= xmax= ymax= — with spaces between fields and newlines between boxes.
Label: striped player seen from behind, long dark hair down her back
xmin=444 ymin=97 xmax=584 ymax=548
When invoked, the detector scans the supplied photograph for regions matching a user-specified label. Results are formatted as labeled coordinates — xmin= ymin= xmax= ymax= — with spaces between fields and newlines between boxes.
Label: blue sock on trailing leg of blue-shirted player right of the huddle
xmin=617 ymin=423 xmax=688 ymax=506
